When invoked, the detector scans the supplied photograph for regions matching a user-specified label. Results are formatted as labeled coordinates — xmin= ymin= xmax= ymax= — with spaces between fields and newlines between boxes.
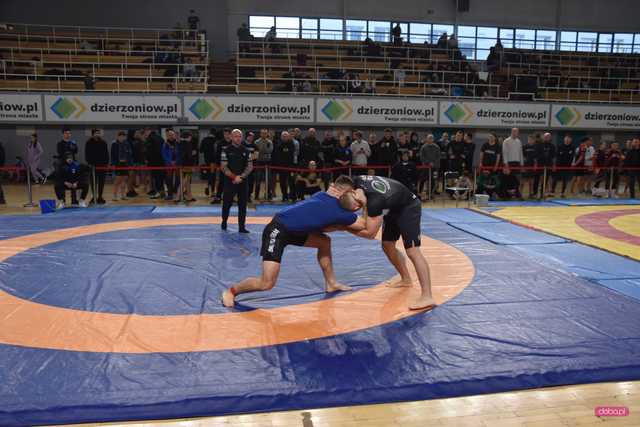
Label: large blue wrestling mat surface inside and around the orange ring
xmin=0 ymin=209 xmax=640 ymax=426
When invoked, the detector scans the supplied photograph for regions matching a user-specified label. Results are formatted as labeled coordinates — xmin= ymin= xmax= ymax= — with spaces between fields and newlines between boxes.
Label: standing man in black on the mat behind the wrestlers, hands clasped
xmin=220 ymin=129 xmax=253 ymax=233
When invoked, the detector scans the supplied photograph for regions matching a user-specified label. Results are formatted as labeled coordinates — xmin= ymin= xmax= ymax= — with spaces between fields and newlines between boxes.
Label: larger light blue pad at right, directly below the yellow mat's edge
xmin=513 ymin=243 xmax=640 ymax=281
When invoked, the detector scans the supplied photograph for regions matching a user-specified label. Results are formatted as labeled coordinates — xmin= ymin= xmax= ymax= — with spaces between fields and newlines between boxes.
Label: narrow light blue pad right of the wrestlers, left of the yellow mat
xmin=449 ymin=222 xmax=567 ymax=245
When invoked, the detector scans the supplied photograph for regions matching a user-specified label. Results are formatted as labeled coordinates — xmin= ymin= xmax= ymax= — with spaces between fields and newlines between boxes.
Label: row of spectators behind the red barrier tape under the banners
xmin=1 ymin=127 xmax=640 ymax=208
